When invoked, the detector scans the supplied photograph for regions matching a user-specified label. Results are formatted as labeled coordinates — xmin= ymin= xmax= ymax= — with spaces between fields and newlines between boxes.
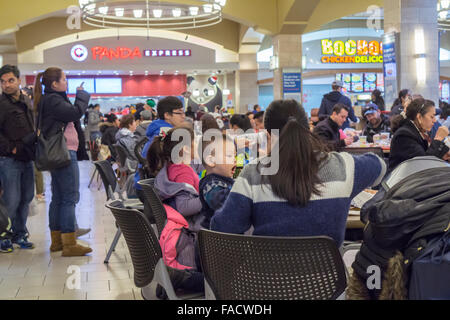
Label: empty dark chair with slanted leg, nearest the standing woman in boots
xmin=94 ymin=160 xmax=144 ymax=263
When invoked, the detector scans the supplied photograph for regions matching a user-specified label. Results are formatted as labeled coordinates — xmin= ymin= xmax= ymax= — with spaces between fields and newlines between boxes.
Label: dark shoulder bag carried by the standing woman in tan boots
xmin=35 ymin=101 xmax=71 ymax=171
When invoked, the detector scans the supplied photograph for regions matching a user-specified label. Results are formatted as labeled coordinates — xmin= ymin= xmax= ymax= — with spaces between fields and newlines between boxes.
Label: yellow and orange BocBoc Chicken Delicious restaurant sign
xmin=321 ymin=39 xmax=383 ymax=64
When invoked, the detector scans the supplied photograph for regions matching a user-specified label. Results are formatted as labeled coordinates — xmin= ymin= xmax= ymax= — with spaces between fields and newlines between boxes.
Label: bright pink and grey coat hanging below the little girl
xmin=159 ymin=204 xmax=197 ymax=270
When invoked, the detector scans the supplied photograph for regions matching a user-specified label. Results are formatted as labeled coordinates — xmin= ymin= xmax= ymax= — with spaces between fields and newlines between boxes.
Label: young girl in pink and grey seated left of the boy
xmin=147 ymin=126 xmax=204 ymax=298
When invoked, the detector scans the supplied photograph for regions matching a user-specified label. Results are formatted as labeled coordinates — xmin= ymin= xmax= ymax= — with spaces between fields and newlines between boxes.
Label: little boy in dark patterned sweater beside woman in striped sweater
xmin=200 ymin=135 xmax=236 ymax=229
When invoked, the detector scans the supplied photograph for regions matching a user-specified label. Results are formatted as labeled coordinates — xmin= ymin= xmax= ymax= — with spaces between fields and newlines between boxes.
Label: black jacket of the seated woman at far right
xmin=389 ymin=120 xmax=450 ymax=171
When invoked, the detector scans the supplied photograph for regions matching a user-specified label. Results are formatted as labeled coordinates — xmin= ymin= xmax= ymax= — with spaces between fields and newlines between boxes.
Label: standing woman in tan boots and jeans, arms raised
xmin=34 ymin=68 xmax=92 ymax=257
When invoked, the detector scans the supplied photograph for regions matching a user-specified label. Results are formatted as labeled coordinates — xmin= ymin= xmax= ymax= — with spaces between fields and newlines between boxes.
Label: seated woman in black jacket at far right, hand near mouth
xmin=389 ymin=99 xmax=449 ymax=171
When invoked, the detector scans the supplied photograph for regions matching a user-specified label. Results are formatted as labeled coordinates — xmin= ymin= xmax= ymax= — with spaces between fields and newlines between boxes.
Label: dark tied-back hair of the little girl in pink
xmin=147 ymin=126 xmax=194 ymax=177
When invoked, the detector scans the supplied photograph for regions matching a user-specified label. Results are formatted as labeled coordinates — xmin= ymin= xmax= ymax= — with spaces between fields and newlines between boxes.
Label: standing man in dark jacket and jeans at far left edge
xmin=0 ymin=65 xmax=36 ymax=252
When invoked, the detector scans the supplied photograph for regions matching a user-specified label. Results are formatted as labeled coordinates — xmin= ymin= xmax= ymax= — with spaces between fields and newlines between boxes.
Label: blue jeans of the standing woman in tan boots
xmin=49 ymin=151 xmax=80 ymax=233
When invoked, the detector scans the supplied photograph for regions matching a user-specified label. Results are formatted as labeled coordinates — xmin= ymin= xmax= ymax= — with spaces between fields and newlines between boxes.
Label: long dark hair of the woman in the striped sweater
xmin=264 ymin=100 xmax=326 ymax=207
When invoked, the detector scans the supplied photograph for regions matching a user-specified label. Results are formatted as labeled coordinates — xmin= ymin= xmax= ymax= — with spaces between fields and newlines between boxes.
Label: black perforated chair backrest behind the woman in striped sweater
xmin=198 ymin=230 xmax=346 ymax=300
